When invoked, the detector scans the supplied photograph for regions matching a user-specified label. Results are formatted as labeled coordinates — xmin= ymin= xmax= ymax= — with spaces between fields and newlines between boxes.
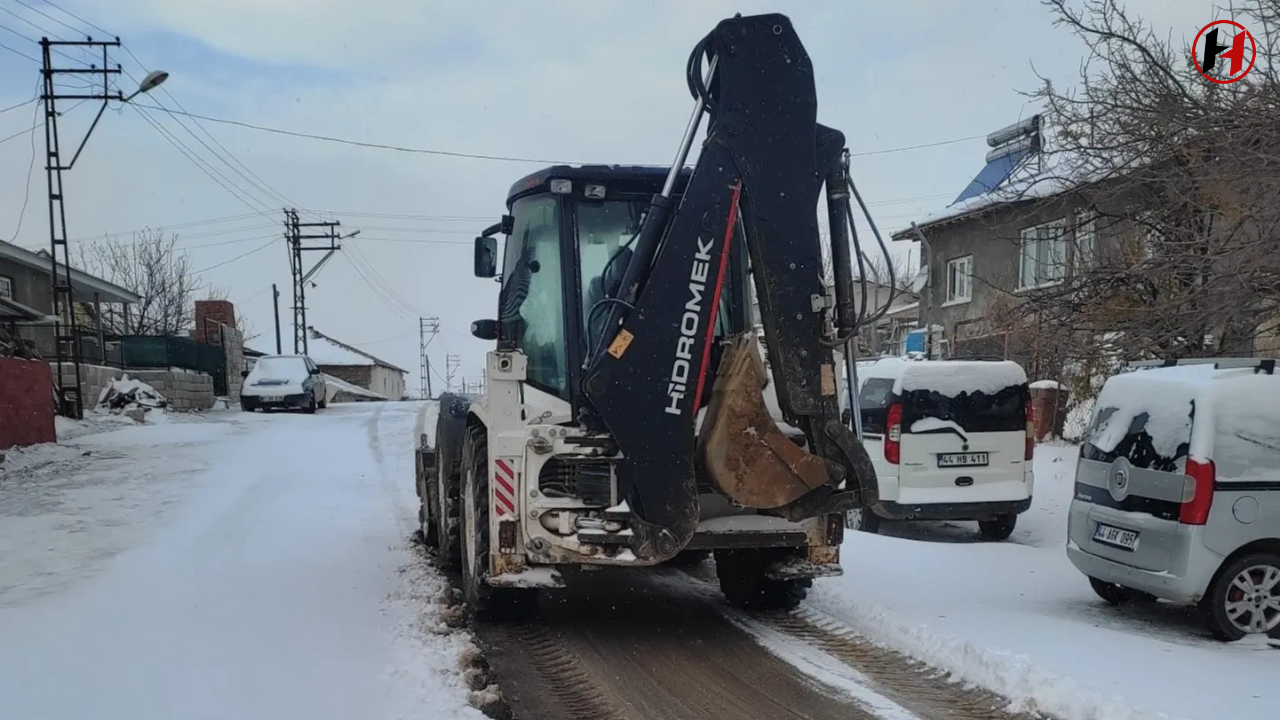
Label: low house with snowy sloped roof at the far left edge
xmin=0 ymin=241 xmax=142 ymax=361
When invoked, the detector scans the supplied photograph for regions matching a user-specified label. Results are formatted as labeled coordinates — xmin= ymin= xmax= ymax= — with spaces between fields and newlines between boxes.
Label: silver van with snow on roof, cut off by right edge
xmin=1066 ymin=359 xmax=1280 ymax=641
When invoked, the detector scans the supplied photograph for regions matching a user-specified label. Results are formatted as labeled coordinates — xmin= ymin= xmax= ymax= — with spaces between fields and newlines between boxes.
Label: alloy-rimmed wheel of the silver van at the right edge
xmin=1204 ymin=552 xmax=1280 ymax=642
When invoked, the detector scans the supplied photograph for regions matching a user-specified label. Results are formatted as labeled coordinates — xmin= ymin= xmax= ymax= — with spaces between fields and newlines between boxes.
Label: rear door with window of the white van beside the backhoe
xmin=899 ymin=382 xmax=1030 ymax=505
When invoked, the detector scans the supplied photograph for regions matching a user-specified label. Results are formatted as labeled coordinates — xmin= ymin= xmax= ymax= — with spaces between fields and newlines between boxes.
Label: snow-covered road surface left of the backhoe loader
xmin=0 ymin=402 xmax=480 ymax=720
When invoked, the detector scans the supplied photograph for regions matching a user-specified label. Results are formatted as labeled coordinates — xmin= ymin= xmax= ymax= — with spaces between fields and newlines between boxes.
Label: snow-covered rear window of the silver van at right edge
xmin=1080 ymin=401 xmax=1196 ymax=473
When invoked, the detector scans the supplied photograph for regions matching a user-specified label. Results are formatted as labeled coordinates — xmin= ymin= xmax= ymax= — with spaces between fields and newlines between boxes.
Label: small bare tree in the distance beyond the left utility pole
xmin=79 ymin=229 xmax=200 ymax=334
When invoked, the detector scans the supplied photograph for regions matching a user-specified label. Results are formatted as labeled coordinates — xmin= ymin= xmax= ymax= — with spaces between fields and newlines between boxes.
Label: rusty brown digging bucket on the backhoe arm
xmin=698 ymin=332 xmax=828 ymax=510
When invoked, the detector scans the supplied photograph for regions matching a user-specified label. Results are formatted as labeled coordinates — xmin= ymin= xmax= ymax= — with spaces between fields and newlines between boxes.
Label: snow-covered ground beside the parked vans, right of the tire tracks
xmin=808 ymin=446 xmax=1280 ymax=720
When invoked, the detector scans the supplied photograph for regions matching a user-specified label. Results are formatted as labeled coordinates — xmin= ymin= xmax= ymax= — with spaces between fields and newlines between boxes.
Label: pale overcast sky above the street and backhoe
xmin=0 ymin=0 xmax=1217 ymax=389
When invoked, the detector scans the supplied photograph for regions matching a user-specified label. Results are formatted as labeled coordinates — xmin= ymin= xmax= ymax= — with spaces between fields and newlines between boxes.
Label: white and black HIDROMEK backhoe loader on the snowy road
xmin=417 ymin=14 xmax=883 ymax=616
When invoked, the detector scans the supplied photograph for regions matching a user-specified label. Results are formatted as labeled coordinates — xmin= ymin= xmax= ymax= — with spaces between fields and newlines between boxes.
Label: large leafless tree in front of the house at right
xmin=992 ymin=0 xmax=1280 ymax=364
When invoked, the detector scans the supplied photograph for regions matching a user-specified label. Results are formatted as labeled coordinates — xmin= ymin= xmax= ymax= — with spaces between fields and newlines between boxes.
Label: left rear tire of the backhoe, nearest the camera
xmin=461 ymin=429 xmax=538 ymax=620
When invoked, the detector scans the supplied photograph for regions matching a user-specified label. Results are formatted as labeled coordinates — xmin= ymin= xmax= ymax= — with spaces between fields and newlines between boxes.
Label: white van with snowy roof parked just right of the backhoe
xmin=846 ymin=357 xmax=1036 ymax=541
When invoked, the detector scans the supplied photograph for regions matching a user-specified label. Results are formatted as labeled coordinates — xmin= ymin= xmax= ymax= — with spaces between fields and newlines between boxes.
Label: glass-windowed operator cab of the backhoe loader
xmin=472 ymin=165 xmax=751 ymax=423
